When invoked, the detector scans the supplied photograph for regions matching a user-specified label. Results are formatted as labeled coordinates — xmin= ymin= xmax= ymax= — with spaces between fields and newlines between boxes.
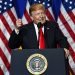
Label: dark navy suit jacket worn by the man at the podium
xmin=9 ymin=21 xmax=68 ymax=49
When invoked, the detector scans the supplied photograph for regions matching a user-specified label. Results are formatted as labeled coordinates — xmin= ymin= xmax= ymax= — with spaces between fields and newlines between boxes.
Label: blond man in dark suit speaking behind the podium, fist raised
xmin=9 ymin=4 xmax=69 ymax=74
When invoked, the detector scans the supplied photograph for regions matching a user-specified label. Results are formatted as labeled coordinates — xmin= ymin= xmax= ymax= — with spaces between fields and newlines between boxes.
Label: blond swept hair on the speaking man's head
xmin=29 ymin=3 xmax=45 ymax=15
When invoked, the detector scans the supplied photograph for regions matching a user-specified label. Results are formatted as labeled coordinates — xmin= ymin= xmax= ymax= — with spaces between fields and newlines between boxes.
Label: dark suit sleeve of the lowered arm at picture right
xmin=55 ymin=24 xmax=69 ymax=49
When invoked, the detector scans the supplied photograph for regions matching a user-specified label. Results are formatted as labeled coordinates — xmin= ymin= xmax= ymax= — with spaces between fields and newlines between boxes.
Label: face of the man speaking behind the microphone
xmin=31 ymin=9 xmax=46 ymax=24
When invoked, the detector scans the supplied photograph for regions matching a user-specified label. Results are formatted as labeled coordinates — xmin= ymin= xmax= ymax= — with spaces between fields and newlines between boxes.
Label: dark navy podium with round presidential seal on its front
xmin=10 ymin=48 xmax=66 ymax=75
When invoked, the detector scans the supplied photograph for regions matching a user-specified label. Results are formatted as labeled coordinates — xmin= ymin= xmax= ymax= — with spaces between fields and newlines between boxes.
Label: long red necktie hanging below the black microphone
xmin=38 ymin=27 xmax=45 ymax=49
